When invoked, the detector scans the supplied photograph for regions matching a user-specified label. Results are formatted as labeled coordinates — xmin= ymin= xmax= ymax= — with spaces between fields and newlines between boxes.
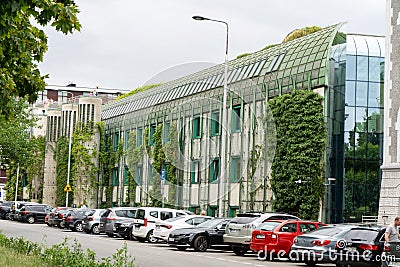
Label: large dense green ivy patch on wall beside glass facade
xmin=269 ymin=90 xmax=326 ymax=220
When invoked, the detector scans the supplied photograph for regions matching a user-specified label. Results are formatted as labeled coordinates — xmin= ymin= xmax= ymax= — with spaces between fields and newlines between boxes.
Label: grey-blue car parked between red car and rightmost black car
xmin=289 ymin=224 xmax=383 ymax=266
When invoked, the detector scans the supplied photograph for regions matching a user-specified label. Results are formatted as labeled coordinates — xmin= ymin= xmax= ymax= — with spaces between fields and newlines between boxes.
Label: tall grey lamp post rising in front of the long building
xmin=192 ymin=16 xmax=229 ymax=217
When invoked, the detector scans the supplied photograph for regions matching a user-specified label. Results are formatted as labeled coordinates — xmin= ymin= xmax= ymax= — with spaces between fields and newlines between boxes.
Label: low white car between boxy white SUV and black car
xmin=153 ymin=215 xmax=212 ymax=242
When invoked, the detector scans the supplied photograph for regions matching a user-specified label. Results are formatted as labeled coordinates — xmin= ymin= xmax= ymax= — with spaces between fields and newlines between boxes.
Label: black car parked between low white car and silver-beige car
xmin=168 ymin=218 xmax=231 ymax=251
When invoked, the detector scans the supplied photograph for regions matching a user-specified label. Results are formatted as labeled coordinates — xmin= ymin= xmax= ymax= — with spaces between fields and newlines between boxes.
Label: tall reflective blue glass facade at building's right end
xmin=344 ymin=35 xmax=385 ymax=224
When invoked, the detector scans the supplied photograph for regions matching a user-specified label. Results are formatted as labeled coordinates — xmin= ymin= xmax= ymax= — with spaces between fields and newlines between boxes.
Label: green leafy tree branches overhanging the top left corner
xmin=0 ymin=0 xmax=81 ymax=117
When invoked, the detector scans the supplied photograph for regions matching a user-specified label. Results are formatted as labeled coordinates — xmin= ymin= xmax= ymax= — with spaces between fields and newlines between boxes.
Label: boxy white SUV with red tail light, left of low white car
xmin=132 ymin=207 xmax=193 ymax=243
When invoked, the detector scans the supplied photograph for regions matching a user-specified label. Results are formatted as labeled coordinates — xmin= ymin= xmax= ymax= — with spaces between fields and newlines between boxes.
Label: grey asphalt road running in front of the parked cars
xmin=0 ymin=220 xmax=334 ymax=267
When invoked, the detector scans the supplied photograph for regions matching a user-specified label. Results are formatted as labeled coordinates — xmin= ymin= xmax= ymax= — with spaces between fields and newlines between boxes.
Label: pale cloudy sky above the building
xmin=39 ymin=0 xmax=386 ymax=90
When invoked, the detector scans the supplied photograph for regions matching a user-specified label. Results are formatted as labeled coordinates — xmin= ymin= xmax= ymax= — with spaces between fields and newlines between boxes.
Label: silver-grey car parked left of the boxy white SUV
xmin=99 ymin=207 xmax=137 ymax=237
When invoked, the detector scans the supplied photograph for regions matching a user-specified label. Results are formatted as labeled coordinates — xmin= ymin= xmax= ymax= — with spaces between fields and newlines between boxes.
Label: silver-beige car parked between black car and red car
xmin=224 ymin=212 xmax=299 ymax=256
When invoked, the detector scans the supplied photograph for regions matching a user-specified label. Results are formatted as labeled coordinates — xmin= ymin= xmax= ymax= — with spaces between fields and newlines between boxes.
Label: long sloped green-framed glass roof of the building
xmin=102 ymin=24 xmax=343 ymax=119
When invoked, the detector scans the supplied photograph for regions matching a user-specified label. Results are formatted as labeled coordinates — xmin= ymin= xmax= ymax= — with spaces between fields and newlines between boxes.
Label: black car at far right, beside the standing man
xmin=335 ymin=226 xmax=386 ymax=267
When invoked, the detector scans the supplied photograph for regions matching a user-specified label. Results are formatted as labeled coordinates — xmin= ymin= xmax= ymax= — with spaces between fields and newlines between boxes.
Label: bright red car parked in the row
xmin=250 ymin=220 xmax=326 ymax=257
